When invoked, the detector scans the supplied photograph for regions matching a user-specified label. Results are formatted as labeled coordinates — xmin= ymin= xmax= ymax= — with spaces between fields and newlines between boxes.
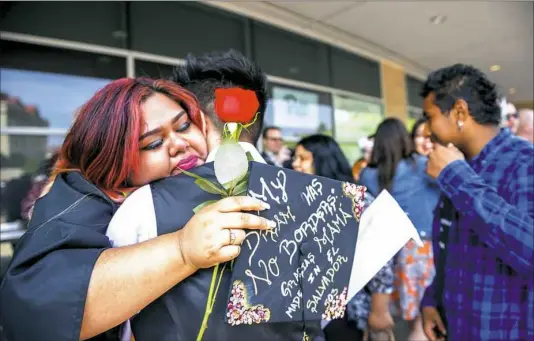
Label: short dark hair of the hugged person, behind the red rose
xmin=171 ymin=50 xmax=267 ymax=144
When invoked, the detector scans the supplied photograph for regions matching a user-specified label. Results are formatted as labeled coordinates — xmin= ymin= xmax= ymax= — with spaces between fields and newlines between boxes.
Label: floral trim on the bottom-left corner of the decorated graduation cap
xmin=226 ymin=281 xmax=271 ymax=326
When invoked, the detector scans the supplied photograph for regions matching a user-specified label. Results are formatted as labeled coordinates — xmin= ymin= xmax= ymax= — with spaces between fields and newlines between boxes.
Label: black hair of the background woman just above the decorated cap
xmin=297 ymin=134 xmax=354 ymax=182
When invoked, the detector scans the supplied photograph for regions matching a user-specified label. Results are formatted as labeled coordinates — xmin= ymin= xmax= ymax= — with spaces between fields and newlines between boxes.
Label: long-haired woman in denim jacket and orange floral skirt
xmin=360 ymin=118 xmax=439 ymax=341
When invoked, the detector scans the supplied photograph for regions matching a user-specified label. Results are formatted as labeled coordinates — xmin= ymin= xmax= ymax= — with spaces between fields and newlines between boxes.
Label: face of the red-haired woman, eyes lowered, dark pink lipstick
xmin=131 ymin=94 xmax=208 ymax=186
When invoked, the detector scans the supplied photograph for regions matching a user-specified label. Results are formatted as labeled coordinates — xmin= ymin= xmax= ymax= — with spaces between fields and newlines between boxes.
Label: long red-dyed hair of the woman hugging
xmin=52 ymin=78 xmax=203 ymax=201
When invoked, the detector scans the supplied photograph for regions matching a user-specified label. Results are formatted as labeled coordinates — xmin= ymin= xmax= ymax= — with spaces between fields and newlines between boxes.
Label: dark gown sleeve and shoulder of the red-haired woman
xmin=0 ymin=172 xmax=121 ymax=341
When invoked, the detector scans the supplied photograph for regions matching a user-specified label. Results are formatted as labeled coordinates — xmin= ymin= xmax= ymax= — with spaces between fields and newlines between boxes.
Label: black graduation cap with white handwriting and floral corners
xmin=226 ymin=162 xmax=365 ymax=325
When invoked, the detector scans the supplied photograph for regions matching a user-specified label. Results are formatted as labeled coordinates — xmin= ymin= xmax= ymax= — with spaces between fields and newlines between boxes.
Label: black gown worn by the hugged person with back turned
xmin=132 ymin=163 xmax=322 ymax=341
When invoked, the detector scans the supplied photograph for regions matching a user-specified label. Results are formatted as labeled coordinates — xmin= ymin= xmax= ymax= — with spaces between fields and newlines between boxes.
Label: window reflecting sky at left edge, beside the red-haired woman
xmin=0 ymin=40 xmax=126 ymax=222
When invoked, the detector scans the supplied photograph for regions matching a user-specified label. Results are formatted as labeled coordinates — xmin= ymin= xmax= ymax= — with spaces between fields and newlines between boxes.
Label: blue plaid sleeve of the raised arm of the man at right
xmin=438 ymin=160 xmax=534 ymax=278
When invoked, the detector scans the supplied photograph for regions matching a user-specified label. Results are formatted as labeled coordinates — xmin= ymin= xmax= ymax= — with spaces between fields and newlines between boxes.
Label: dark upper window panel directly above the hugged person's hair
xmin=130 ymin=1 xmax=246 ymax=58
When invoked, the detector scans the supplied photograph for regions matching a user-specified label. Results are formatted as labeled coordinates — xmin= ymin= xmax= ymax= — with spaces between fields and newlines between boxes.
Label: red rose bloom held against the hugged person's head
xmin=215 ymin=88 xmax=260 ymax=124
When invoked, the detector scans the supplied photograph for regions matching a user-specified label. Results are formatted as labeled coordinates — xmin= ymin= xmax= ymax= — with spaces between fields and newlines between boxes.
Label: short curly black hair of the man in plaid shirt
xmin=421 ymin=64 xmax=501 ymax=125
